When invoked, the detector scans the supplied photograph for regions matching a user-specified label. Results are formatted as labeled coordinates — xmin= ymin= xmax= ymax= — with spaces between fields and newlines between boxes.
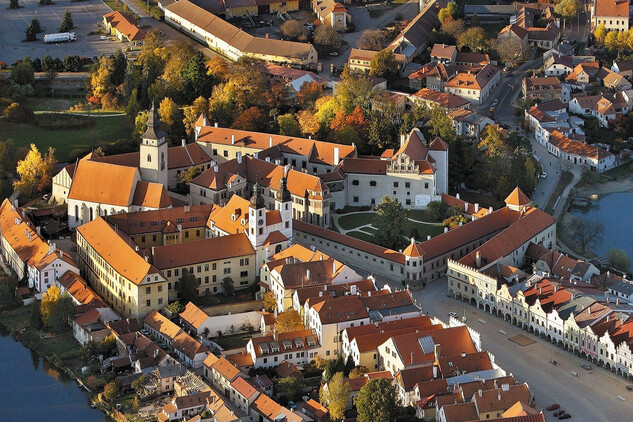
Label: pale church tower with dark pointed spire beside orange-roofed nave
xmin=139 ymin=103 xmax=169 ymax=186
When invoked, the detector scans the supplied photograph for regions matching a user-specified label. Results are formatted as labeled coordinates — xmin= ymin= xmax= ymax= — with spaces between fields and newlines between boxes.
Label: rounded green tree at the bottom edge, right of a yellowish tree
xmin=356 ymin=378 xmax=399 ymax=422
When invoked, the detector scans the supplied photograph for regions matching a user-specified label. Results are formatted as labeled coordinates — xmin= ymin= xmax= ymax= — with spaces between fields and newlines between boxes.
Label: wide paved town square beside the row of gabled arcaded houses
xmin=404 ymin=278 xmax=633 ymax=422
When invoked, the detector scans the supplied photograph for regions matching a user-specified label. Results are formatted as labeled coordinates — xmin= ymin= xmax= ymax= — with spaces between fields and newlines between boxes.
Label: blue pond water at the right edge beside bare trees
xmin=571 ymin=192 xmax=633 ymax=257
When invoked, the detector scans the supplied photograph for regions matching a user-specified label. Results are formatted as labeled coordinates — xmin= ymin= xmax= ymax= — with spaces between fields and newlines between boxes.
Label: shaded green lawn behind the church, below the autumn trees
xmin=0 ymin=116 xmax=132 ymax=162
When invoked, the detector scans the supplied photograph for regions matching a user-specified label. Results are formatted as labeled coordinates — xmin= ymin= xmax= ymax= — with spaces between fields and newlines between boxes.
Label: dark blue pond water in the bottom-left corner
xmin=0 ymin=331 xmax=106 ymax=422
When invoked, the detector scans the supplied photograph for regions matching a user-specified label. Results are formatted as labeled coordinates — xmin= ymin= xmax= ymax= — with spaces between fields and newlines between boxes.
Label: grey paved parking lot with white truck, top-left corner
xmin=0 ymin=0 xmax=122 ymax=64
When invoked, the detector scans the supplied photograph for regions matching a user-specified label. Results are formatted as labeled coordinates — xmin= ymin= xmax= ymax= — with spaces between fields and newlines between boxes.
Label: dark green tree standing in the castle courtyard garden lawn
xmin=374 ymin=196 xmax=408 ymax=250
